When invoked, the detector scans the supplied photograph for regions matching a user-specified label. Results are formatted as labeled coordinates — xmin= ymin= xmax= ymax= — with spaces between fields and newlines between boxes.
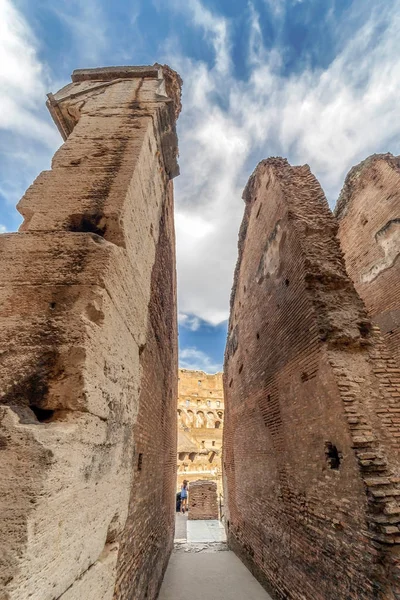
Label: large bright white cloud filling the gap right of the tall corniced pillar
xmin=168 ymin=0 xmax=400 ymax=324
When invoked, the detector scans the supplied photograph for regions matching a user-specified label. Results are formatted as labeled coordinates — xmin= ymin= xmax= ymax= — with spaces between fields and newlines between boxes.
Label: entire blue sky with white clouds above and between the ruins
xmin=0 ymin=0 xmax=400 ymax=372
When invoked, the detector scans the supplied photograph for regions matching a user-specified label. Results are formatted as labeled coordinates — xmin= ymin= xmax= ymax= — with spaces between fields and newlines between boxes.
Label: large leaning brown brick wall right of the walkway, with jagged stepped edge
xmin=223 ymin=159 xmax=400 ymax=600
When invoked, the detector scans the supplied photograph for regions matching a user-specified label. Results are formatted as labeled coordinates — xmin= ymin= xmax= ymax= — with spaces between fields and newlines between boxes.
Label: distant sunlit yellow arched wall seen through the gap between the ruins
xmin=177 ymin=369 xmax=224 ymax=494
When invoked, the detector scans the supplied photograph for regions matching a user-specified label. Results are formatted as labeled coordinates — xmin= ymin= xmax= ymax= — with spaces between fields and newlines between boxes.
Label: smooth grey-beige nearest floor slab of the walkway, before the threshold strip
xmin=158 ymin=550 xmax=271 ymax=600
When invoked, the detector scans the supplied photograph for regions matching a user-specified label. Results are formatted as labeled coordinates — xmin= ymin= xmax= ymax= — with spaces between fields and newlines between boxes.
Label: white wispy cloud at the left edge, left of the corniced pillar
xmin=0 ymin=0 xmax=61 ymax=229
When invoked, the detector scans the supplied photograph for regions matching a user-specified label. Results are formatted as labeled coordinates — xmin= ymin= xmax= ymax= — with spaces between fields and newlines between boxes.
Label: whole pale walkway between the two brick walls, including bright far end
xmin=158 ymin=514 xmax=271 ymax=600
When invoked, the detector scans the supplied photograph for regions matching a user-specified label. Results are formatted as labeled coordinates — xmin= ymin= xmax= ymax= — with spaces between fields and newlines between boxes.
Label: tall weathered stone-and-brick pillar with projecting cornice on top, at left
xmin=0 ymin=65 xmax=181 ymax=600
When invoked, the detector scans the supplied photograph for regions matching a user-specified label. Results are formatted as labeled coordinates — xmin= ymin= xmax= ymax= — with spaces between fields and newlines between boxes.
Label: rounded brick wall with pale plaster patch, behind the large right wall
xmin=335 ymin=154 xmax=400 ymax=365
